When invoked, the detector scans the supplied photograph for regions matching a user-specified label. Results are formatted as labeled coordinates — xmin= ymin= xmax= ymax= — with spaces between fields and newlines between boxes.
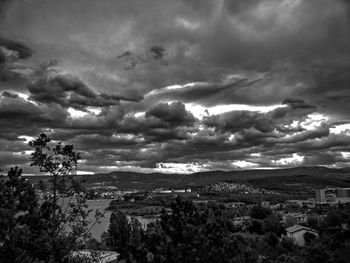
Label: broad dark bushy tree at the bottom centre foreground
xmin=123 ymin=198 xmax=249 ymax=263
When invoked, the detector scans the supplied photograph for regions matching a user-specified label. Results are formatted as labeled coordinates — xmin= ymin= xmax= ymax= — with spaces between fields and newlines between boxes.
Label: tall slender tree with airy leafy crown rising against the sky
xmin=29 ymin=133 xmax=103 ymax=262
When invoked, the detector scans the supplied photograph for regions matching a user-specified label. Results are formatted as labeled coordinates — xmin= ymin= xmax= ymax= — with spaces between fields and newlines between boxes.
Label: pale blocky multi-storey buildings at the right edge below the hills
xmin=315 ymin=188 xmax=350 ymax=204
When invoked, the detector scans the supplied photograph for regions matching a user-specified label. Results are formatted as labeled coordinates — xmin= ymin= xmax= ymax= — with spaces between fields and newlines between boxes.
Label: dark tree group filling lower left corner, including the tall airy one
xmin=0 ymin=134 xmax=102 ymax=263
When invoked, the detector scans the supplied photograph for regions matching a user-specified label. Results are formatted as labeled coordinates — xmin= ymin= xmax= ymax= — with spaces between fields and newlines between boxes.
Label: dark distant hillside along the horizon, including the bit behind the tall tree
xmin=24 ymin=167 xmax=350 ymax=190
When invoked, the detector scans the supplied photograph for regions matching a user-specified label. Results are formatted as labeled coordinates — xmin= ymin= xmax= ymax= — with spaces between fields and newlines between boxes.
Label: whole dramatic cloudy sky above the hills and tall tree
xmin=0 ymin=0 xmax=350 ymax=173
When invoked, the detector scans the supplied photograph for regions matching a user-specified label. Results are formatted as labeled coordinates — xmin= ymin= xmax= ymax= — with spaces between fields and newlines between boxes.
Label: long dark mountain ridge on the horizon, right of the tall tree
xmin=82 ymin=166 xmax=350 ymax=189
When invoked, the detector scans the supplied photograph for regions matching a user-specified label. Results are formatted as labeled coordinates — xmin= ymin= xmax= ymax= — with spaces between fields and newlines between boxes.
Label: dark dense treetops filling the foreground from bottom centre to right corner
xmin=104 ymin=198 xmax=350 ymax=263
